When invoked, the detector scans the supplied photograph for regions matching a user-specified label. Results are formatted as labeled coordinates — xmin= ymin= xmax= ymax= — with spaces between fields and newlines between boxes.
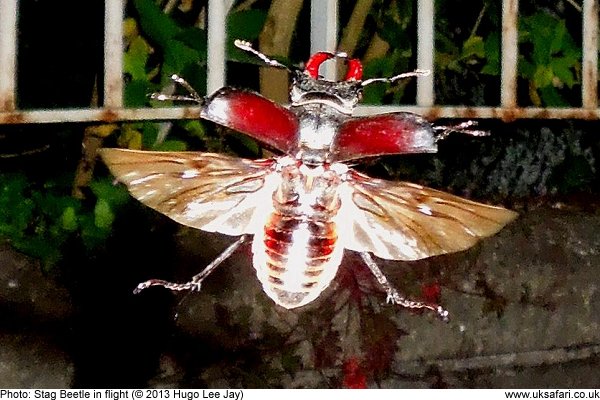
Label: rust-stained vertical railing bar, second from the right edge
xmin=500 ymin=0 xmax=519 ymax=108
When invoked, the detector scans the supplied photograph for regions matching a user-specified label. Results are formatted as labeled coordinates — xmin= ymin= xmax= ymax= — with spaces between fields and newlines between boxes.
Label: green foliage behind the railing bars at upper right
xmin=436 ymin=6 xmax=581 ymax=107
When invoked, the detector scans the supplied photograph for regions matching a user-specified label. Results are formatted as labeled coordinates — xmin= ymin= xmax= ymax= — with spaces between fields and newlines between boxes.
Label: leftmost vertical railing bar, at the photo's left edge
xmin=0 ymin=0 xmax=18 ymax=111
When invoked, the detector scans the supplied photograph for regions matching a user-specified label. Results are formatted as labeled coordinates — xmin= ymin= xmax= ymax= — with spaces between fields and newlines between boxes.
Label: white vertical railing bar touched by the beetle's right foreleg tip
xmin=417 ymin=0 xmax=435 ymax=107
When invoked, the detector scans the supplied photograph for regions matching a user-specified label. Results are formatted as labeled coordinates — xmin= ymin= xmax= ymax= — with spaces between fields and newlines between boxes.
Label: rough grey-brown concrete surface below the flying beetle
xmin=0 ymin=203 xmax=600 ymax=388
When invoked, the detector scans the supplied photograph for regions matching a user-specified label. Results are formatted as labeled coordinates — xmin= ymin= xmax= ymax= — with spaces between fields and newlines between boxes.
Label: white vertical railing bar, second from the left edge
xmin=104 ymin=0 xmax=124 ymax=108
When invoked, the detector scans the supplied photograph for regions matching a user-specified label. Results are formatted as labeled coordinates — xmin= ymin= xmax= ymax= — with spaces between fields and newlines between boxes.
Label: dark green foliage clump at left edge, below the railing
xmin=0 ymin=173 xmax=129 ymax=269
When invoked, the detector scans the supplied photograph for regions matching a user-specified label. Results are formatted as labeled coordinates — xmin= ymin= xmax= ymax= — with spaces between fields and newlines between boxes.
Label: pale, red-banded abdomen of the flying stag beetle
xmin=253 ymin=212 xmax=343 ymax=309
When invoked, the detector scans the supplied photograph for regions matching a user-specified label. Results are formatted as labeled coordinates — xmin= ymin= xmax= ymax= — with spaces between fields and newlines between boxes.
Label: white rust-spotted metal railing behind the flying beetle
xmin=0 ymin=0 xmax=600 ymax=124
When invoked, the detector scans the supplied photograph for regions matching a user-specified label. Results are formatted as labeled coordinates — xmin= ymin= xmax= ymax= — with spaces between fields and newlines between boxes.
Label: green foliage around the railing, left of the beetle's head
xmin=117 ymin=0 xmax=266 ymax=151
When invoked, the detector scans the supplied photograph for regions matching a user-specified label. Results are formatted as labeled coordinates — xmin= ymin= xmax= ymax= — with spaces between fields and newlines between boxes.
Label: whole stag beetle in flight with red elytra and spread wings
xmin=101 ymin=41 xmax=516 ymax=319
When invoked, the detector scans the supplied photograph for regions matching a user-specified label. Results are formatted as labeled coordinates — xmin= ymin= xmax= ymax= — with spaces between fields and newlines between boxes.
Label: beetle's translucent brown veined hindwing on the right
xmin=340 ymin=171 xmax=517 ymax=261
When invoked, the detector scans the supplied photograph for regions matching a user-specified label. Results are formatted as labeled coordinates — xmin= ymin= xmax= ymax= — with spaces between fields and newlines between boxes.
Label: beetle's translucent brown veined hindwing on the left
xmin=100 ymin=149 xmax=279 ymax=236
